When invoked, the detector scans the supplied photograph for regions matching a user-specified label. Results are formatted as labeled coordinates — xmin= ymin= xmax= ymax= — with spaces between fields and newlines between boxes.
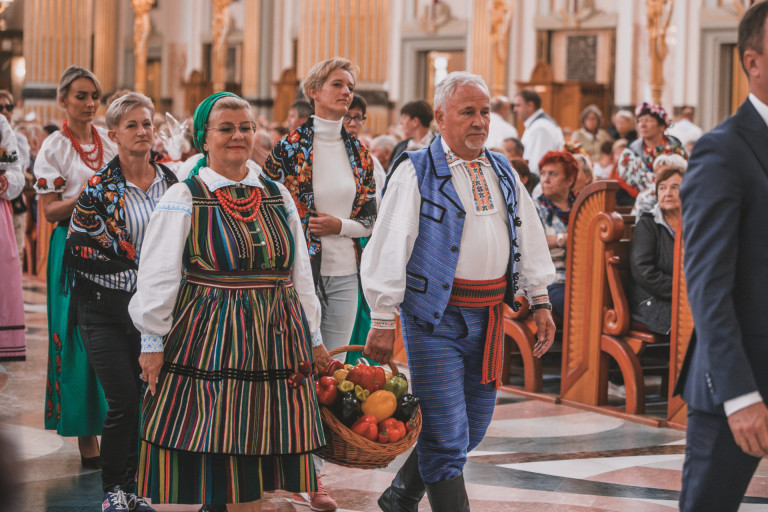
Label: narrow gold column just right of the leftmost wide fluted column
xmin=93 ymin=0 xmax=118 ymax=94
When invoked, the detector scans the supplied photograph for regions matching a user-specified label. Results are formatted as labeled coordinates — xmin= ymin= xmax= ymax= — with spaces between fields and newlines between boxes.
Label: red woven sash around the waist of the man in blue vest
xmin=448 ymin=276 xmax=507 ymax=389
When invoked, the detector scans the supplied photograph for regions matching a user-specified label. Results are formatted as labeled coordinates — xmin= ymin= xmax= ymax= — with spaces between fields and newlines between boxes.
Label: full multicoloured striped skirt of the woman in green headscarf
xmin=138 ymin=272 xmax=325 ymax=503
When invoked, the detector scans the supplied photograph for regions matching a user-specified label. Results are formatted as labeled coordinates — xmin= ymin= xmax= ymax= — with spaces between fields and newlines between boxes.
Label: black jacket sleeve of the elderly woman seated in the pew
xmin=629 ymin=215 xmax=672 ymax=300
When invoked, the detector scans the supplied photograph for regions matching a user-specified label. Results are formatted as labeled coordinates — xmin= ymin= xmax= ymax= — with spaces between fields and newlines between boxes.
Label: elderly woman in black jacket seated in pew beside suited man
xmin=629 ymin=166 xmax=684 ymax=334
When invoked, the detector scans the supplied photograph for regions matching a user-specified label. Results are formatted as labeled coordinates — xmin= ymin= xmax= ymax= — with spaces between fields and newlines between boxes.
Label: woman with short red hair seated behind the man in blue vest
xmin=533 ymin=151 xmax=579 ymax=317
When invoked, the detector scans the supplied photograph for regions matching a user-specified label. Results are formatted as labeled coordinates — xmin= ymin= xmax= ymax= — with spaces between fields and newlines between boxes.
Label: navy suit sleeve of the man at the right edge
xmin=680 ymin=133 xmax=757 ymax=404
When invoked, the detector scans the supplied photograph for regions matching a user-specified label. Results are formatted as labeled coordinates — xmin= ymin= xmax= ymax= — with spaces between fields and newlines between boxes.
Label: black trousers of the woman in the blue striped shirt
xmin=76 ymin=292 xmax=142 ymax=491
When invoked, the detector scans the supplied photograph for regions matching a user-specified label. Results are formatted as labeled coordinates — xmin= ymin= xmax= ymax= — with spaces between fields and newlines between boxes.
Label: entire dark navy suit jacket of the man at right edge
xmin=677 ymin=99 xmax=768 ymax=413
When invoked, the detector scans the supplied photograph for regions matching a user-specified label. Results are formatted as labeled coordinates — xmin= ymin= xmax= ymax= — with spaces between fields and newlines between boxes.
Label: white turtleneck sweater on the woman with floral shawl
xmin=312 ymin=116 xmax=371 ymax=276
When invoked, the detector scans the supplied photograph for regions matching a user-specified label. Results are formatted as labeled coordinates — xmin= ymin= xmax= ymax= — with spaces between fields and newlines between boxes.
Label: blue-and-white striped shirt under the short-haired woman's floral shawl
xmin=87 ymin=166 xmax=171 ymax=292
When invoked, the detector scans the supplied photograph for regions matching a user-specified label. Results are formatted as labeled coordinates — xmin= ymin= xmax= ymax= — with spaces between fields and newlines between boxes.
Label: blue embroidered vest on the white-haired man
xmin=393 ymin=136 xmax=520 ymax=325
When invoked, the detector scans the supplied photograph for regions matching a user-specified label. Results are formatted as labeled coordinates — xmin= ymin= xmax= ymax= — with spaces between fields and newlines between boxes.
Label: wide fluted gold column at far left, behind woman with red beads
xmin=21 ymin=0 xmax=93 ymax=121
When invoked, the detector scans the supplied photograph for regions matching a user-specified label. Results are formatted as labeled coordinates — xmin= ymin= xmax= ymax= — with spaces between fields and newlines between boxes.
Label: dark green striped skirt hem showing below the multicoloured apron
xmin=138 ymin=441 xmax=317 ymax=505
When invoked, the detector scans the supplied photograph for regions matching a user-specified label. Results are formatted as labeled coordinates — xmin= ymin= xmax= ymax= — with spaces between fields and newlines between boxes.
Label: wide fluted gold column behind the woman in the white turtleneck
xmin=297 ymin=0 xmax=389 ymax=133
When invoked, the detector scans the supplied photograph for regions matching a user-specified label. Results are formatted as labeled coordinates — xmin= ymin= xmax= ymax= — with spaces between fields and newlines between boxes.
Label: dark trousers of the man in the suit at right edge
xmin=680 ymin=407 xmax=760 ymax=512
